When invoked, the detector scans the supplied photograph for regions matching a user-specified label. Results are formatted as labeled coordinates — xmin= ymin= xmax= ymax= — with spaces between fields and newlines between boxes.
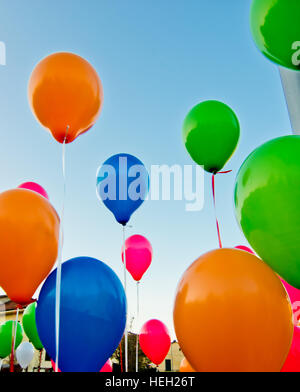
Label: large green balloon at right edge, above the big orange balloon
xmin=234 ymin=135 xmax=300 ymax=289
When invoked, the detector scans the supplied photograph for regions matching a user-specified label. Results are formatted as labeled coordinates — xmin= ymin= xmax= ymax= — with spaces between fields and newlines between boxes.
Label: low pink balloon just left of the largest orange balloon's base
xmin=139 ymin=319 xmax=171 ymax=365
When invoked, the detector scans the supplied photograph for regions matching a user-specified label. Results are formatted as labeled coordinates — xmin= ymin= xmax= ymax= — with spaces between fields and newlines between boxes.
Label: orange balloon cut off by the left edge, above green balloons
xmin=0 ymin=188 xmax=59 ymax=305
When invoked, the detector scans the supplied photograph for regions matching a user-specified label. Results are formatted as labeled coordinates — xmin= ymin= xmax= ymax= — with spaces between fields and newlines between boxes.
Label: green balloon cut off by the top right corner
xmin=250 ymin=0 xmax=300 ymax=70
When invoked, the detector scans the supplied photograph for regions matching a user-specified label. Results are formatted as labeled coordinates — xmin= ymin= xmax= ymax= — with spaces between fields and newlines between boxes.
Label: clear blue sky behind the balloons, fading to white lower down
xmin=0 ymin=0 xmax=291 ymax=338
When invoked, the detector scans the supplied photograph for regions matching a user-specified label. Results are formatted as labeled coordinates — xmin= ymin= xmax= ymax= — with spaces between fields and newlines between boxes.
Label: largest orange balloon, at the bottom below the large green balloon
xmin=174 ymin=249 xmax=293 ymax=372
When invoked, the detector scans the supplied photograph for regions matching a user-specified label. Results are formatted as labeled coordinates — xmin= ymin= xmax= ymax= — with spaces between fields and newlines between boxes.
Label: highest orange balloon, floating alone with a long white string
xmin=28 ymin=52 xmax=103 ymax=143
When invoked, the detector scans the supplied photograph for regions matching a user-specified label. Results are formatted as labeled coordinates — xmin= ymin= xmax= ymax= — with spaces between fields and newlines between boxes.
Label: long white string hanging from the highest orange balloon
xmin=55 ymin=125 xmax=69 ymax=372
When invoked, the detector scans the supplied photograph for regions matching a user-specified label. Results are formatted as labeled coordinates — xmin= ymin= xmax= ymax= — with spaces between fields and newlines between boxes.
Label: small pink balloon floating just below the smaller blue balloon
xmin=122 ymin=234 xmax=152 ymax=282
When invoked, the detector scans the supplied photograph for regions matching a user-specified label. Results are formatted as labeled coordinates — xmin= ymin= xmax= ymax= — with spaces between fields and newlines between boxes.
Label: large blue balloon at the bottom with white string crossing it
xmin=36 ymin=257 xmax=126 ymax=372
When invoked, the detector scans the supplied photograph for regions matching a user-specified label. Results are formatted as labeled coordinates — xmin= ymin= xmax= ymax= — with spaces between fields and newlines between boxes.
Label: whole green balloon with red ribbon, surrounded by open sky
xmin=182 ymin=101 xmax=240 ymax=173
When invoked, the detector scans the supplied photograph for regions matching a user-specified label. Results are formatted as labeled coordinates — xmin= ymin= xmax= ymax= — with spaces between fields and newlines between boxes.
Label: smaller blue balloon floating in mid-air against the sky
xmin=97 ymin=154 xmax=149 ymax=226
